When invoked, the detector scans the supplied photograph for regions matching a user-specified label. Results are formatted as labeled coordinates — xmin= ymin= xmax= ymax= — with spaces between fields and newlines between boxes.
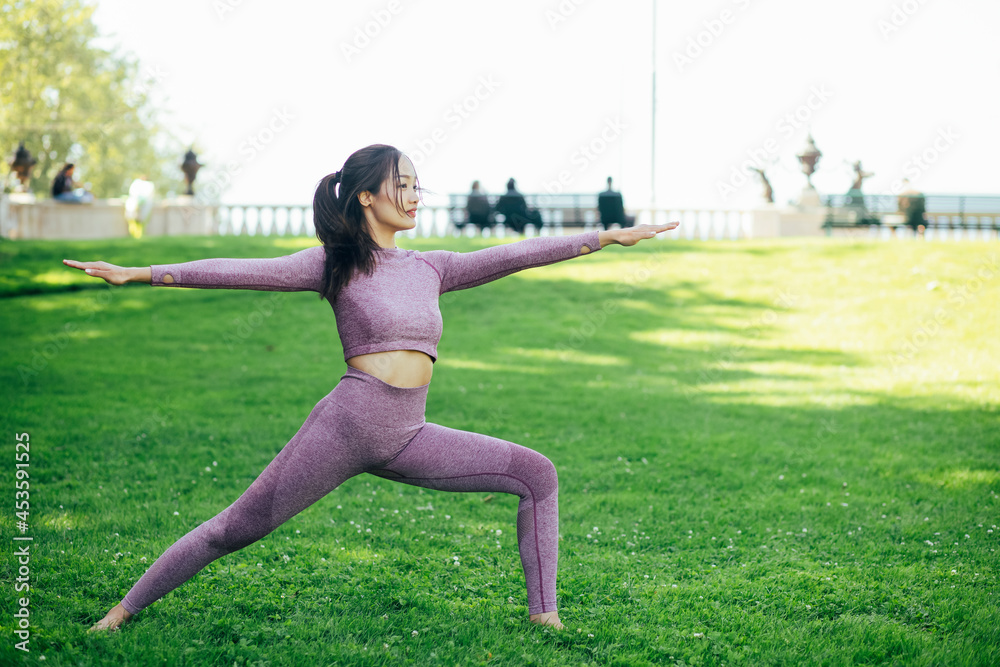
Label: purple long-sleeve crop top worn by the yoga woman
xmin=150 ymin=231 xmax=601 ymax=361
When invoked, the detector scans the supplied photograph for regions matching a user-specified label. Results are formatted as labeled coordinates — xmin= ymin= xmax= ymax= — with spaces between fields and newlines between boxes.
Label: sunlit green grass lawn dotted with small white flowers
xmin=0 ymin=232 xmax=1000 ymax=666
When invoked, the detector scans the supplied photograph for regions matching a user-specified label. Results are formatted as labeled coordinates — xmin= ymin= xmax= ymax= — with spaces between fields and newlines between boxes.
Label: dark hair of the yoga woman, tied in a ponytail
xmin=313 ymin=144 xmax=404 ymax=301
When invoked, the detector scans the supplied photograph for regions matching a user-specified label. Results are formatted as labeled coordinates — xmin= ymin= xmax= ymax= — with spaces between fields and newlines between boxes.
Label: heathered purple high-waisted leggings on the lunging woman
xmin=122 ymin=366 xmax=559 ymax=614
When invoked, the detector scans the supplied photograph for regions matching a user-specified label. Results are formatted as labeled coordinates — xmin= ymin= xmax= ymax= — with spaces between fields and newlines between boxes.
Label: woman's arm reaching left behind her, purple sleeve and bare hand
xmin=63 ymin=246 xmax=326 ymax=292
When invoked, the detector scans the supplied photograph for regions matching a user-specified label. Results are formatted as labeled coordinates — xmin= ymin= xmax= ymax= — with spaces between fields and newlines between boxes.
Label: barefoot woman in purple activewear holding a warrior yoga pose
xmin=63 ymin=144 xmax=677 ymax=630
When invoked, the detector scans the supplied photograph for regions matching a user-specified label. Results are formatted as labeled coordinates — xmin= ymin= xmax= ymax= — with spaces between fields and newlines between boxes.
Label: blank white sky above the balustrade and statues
xmin=95 ymin=0 xmax=1000 ymax=208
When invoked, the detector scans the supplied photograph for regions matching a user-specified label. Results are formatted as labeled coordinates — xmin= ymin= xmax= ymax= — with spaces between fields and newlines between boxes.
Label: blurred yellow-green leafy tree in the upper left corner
xmin=0 ymin=0 xmax=180 ymax=197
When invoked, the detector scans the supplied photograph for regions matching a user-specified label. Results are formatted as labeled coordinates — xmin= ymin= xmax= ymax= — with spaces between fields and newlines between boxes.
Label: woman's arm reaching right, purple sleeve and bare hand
xmin=422 ymin=222 xmax=678 ymax=293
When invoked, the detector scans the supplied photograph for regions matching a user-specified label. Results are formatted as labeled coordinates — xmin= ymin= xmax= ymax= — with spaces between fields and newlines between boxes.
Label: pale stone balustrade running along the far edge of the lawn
xmin=0 ymin=195 xmax=1000 ymax=241
